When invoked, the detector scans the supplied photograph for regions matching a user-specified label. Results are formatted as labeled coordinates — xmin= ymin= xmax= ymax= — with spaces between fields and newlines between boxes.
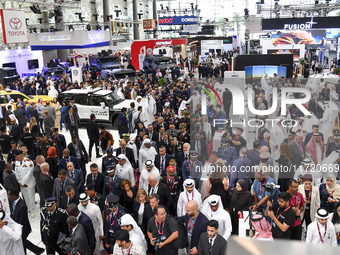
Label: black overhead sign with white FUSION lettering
xmin=262 ymin=17 xmax=340 ymax=30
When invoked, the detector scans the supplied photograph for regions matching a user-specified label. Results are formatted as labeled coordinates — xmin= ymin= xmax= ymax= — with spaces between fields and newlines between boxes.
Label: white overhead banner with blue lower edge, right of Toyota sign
xmin=28 ymin=30 xmax=110 ymax=50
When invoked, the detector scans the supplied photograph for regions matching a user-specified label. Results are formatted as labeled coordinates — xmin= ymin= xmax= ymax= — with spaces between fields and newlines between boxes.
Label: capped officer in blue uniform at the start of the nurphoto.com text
xmin=182 ymin=151 xmax=203 ymax=190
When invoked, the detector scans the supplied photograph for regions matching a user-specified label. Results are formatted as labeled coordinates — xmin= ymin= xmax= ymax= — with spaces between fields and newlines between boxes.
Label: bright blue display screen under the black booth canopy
xmin=246 ymin=66 xmax=287 ymax=79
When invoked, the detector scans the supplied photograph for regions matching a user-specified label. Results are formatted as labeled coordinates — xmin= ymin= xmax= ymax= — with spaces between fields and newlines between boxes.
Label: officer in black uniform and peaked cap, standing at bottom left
xmin=40 ymin=197 xmax=69 ymax=254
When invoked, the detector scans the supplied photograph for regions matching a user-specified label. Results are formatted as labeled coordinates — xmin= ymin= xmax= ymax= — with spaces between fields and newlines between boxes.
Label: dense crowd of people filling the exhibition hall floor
xmin=0 ymin=57 xmax=340 ymax=255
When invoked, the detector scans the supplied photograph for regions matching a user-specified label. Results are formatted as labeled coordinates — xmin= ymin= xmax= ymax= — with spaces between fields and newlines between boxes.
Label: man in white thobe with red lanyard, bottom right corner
xmin=306 ymin=208 xmax=338 ymax=246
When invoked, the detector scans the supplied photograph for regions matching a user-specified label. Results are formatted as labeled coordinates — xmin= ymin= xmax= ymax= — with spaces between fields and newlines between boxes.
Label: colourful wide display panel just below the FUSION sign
xmin=270 ymin=30 xmax=326 ymax=45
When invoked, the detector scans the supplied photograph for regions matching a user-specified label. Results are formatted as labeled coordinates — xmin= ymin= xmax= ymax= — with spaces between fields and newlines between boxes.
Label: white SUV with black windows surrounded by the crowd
xmin=58 ymin=88 xmax=133 ymax=127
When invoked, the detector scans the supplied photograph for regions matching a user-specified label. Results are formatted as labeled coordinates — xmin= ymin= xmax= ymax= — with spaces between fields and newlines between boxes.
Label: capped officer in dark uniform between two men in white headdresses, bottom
xmin=104 ymin=195 xmax=126 ymax=254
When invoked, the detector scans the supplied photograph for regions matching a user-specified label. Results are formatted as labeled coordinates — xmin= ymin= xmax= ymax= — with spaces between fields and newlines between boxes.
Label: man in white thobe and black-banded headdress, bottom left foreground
xmin=78 ymin=193 xmax=104 ymax=255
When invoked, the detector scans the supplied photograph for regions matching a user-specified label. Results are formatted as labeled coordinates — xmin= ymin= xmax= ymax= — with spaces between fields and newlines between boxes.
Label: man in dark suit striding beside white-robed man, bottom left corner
xmin=8 ymin=188 xmax=45 ymax=254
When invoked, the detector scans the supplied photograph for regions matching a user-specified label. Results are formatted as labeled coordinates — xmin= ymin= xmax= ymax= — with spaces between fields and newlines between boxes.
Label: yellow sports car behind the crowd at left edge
xmin=0 ymin=90 xmax=53 ymax=110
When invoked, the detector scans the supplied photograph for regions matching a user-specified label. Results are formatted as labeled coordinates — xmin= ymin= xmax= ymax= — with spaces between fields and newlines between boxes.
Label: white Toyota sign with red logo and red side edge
xmin=0 ymin=9 xmax=28 ymax=44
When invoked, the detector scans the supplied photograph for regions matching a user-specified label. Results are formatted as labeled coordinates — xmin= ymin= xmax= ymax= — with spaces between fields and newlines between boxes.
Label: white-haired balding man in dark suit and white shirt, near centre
xmin=148 ymin=174 xmax=172 ymax=210
